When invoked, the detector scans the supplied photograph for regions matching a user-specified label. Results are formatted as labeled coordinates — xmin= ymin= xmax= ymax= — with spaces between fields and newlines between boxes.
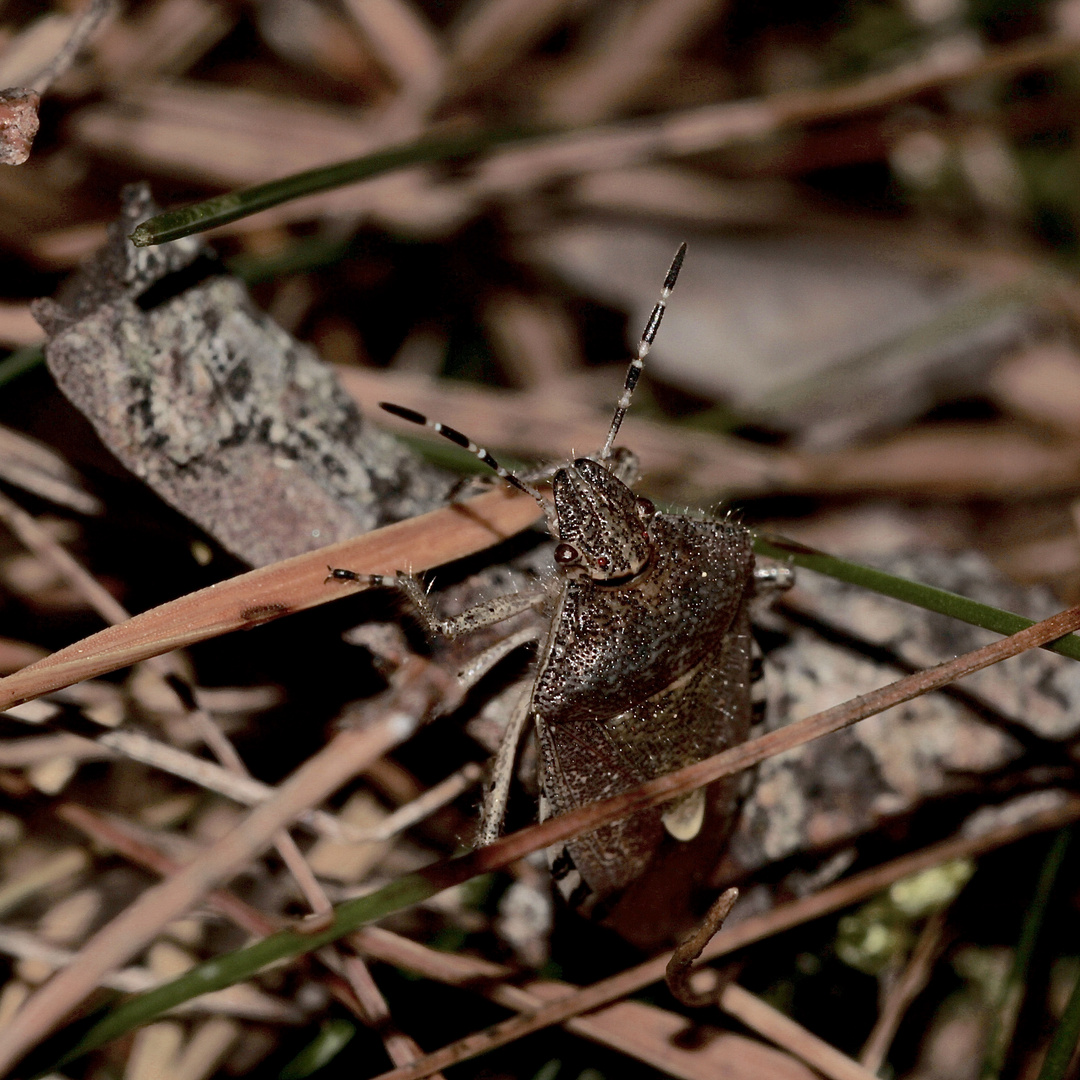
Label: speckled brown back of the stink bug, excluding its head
xmin=532 ymin=515 xmax=754 ymax=904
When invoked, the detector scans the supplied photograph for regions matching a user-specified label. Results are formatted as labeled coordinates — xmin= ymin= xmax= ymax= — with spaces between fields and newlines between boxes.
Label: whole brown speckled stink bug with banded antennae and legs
xmin=330 ymin=244 xmax=754 ymax=943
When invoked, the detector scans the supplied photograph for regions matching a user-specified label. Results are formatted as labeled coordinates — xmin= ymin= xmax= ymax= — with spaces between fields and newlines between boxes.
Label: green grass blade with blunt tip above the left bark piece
xmin=131 ymin=131 xmax=538 ymax=247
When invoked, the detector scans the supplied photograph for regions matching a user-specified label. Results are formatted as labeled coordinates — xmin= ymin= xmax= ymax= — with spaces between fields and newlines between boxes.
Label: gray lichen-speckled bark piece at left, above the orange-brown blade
xmin=33 ymin=185 xmax=448 ymax=566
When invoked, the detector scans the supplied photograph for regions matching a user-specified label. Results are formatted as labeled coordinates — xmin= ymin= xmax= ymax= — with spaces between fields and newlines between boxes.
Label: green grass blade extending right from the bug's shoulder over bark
xmin=754 ymin=534 xmax=1080 ymax=660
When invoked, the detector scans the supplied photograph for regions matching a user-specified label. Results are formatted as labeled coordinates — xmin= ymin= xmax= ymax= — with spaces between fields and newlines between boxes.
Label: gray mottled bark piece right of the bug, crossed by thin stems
xmin=719 ymin=551 xmax=1080 ymax=878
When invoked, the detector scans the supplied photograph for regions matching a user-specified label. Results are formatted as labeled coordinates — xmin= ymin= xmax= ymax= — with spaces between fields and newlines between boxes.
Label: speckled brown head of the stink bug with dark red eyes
xmin=552 ymin=458 xmax=656 ymax=581
